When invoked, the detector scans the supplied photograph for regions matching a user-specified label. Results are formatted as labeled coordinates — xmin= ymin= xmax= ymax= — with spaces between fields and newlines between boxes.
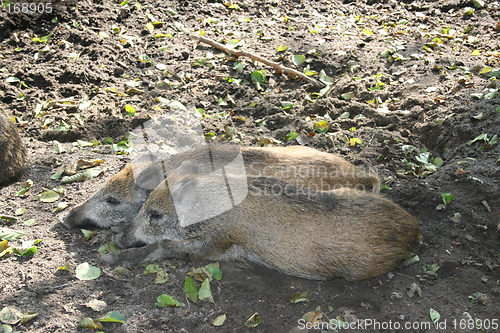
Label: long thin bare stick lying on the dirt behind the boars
xmin=184 ymin=31 xmax=325 ymax=87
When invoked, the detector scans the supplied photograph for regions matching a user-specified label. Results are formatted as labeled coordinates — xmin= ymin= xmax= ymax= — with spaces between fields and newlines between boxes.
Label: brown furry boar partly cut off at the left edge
xmin=0 ymin=113 xmax=26 ymax=185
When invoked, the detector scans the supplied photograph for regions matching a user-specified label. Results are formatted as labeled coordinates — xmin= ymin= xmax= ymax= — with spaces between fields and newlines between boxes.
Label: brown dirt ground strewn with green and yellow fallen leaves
xmin=0 ymin=0 xmax=500 ymax=332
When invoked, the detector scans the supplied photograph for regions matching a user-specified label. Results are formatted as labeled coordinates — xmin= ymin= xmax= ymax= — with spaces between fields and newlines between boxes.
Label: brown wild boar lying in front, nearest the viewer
xmin=103 ymin=173 xmax=421 ymax=280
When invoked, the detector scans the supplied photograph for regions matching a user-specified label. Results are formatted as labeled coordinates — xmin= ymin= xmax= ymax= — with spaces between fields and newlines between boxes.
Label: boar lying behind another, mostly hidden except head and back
xmin=63 ymin=144 xmax=380 ymax=232
